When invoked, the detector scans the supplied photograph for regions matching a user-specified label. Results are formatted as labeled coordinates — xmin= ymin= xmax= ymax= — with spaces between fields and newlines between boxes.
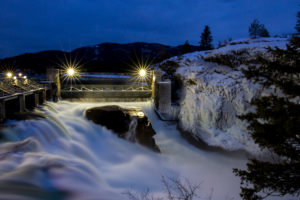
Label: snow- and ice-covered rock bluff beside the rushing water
xmin=155 ymin=38 xmax=287 ymax=154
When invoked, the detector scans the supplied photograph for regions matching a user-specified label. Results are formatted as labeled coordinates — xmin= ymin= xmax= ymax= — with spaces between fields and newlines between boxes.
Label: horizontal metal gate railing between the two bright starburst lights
xmin=61 ymin=73 xmax=152 ymax=98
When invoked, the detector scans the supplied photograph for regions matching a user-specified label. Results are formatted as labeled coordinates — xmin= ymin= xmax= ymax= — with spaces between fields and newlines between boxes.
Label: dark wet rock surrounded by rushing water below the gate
xmin=86 ymin=105 xmax=160 ymax=152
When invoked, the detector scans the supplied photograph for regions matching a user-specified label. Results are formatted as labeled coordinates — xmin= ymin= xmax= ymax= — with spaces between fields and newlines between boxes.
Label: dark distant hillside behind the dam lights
xmin=0 ymin=42 xmax=198 ymax=73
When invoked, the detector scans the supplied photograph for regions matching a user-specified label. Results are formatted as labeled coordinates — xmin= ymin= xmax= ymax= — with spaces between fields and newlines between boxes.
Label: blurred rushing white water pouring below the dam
xmin=0 ymin=101 xmax=246 ymax=200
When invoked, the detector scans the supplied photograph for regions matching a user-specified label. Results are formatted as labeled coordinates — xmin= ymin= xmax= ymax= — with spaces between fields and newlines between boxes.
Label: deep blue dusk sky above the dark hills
xmin=0 ymin=0 xmax=300 ymax=58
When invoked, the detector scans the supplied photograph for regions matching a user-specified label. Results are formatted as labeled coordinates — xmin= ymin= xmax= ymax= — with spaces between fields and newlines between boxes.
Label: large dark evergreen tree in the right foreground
xmin=234 ymin=38 xmax=300 ymax=200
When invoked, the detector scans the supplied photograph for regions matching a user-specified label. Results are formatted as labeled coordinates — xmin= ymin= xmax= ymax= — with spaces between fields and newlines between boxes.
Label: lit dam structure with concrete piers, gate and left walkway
xmin=0 ymin=69 xmax=171 ymax=121
